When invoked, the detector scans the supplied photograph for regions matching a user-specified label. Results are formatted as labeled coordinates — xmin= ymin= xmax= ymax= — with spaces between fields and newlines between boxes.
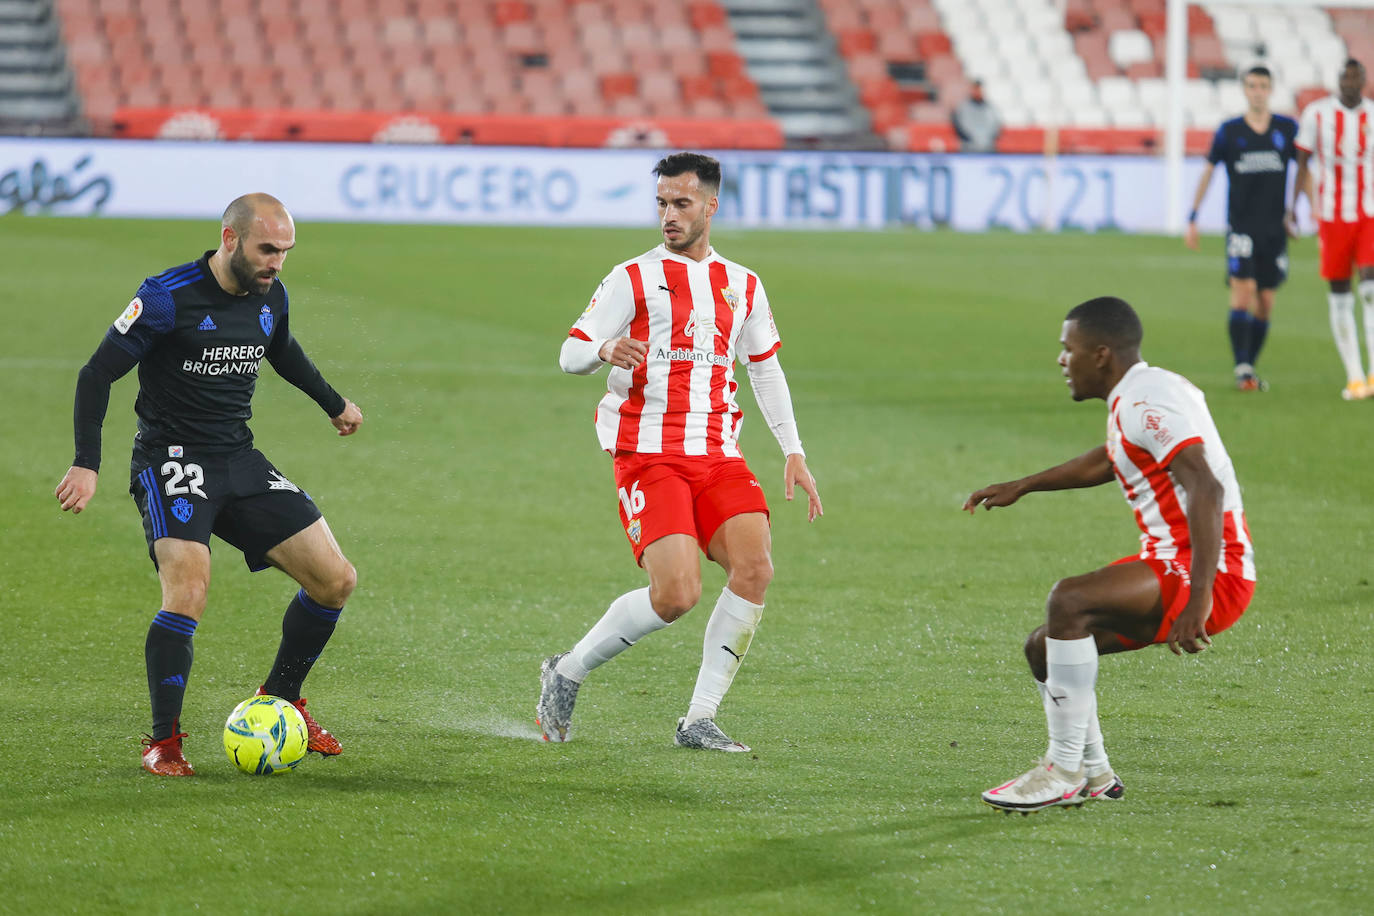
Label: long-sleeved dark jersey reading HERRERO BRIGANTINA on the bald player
xmin=74 ymin=251 xmax=344 ymax=468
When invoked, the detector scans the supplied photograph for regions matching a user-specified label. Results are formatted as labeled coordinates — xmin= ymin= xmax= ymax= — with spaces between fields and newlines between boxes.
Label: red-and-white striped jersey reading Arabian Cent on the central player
xmin=569 ymin=244 xmax=782 ymax=457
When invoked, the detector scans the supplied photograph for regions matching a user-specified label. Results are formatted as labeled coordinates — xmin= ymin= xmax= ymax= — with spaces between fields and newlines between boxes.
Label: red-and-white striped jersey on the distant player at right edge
xmin=1297 ymin=95 xmax=1374 ymax=222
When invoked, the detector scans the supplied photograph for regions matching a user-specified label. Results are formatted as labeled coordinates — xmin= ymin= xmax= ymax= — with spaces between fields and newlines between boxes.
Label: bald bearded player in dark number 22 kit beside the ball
xmin=55 ymin=194 xmax=363 ymax=776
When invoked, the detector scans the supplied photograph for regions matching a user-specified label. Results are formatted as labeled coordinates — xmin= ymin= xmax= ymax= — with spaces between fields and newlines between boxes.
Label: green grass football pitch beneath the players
xmin=0 ymin=217 xmax=1374 ymax=913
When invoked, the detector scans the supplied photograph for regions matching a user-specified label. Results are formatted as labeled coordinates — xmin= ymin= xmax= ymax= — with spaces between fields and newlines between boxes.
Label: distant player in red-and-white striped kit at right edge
xmin=1290 ymin=59 xmax=1374 ymax=401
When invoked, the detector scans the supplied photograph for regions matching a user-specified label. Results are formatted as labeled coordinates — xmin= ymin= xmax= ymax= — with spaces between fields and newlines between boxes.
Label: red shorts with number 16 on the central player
xmin=616 ymin=452 xmax=768 ymax=563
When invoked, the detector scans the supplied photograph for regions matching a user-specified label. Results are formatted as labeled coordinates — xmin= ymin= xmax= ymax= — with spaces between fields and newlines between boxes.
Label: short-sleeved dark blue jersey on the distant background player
xmin=1206 ymin=114 xmax=1297 ymax=238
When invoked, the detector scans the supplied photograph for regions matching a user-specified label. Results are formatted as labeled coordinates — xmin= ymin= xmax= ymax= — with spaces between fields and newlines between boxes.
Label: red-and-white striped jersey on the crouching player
xmin=1107 ymin=361 xmax=1254 ymax=581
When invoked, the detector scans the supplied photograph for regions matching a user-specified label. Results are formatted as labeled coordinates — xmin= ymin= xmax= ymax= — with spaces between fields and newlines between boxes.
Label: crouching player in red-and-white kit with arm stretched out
xmin=963 ymin=297 xmax=1254 ymax=813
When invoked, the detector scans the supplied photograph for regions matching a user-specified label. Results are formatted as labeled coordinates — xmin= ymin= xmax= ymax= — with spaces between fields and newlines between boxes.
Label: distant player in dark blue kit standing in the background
xmin=1183 ymin=67 xmax=1297 ymax=391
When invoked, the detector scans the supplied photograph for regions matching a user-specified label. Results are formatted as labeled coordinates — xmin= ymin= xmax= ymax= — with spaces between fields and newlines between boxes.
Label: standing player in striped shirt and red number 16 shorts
xmin=536 ymin=152 xmax=822 ymax=751
